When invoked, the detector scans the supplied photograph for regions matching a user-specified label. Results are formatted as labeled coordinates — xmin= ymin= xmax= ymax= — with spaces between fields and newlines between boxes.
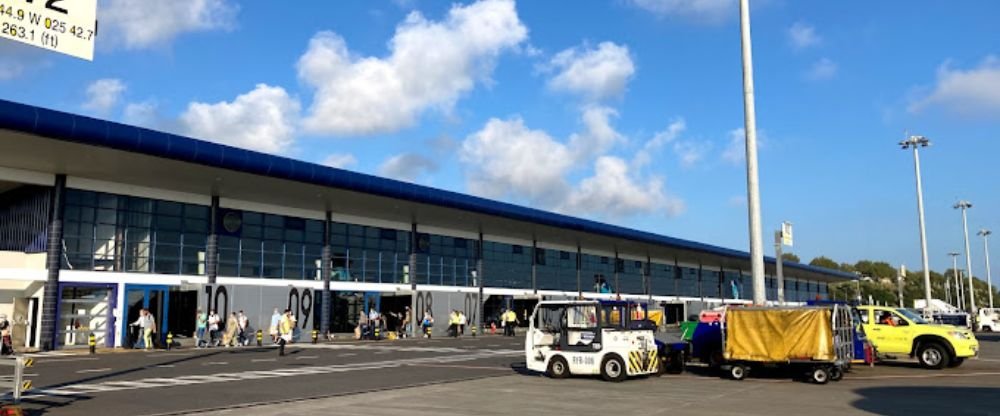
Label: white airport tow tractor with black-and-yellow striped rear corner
xmin=524 ymin=301 xmax=660 ymax=381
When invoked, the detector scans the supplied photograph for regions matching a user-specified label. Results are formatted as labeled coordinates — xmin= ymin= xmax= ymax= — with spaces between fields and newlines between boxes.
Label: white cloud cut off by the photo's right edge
xmin=909 ymin=55 xmax=1000 ymax=118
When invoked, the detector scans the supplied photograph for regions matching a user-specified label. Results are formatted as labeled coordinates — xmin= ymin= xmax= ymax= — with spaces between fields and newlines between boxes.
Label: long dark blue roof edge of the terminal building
xmin=0 ymin=100 xmax=855 ymax=279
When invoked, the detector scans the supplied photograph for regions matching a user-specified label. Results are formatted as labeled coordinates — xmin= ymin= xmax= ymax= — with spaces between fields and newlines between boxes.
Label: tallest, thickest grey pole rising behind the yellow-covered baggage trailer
xmin=740 ymin=0 xmax=767 ymax=305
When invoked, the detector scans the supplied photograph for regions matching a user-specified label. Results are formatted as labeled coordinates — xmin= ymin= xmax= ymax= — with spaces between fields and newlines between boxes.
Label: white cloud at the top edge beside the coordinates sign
xmin=98 ymin=0 xmax=239 ymax=49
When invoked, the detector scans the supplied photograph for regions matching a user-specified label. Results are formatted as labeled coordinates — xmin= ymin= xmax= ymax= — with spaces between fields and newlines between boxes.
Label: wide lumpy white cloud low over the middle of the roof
xmin=461 ymin=114 xmax=684 ymax=217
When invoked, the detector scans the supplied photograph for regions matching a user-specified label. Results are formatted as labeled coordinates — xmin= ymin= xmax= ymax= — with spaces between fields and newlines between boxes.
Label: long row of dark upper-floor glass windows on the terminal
xmin=56 ymin=189 xmax=828 ymax=302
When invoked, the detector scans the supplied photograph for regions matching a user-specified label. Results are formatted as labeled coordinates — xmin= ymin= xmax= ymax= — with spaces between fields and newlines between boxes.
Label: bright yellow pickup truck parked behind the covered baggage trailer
xmin=857 ymin=306 xmax=979 ymax=369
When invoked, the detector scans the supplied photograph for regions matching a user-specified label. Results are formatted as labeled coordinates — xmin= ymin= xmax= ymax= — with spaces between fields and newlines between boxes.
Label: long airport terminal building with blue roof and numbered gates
xmin=0 ymin=101 xmax=854 ymax=349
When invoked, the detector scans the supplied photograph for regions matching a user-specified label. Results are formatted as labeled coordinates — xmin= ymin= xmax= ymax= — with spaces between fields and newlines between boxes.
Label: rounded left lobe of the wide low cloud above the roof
xmin=460 ymin=118 xmax=573 ymax=206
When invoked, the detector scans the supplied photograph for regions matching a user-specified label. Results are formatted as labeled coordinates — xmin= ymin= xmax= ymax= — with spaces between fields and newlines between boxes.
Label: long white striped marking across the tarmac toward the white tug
xmin=25 ymin=351 xmax=524 ymax=398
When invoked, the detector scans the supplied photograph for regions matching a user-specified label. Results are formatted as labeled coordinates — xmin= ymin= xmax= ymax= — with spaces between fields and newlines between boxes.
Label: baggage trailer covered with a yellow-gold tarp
xmin=720 ymin=305 xmax=854 ymax=384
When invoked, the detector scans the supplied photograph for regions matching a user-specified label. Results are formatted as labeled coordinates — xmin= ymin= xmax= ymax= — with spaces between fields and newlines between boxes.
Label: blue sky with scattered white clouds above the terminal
xmin=0 ymin=0 xmax=1000 ymax=274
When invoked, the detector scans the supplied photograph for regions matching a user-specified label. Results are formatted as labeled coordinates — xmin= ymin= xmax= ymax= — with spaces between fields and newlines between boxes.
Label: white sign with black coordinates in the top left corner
xmin=0 ymin=0 xmax=97 ymax=61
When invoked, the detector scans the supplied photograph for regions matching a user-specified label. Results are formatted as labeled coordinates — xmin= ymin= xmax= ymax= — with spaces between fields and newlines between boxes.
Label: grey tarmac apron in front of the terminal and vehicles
xmin=5 ymin=334 xmax=1000 ymax=416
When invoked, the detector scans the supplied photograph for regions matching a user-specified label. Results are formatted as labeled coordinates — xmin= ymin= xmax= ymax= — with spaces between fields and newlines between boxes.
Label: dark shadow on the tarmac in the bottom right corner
xmin=851 ymin=386 xmax=1000 ymax=416
